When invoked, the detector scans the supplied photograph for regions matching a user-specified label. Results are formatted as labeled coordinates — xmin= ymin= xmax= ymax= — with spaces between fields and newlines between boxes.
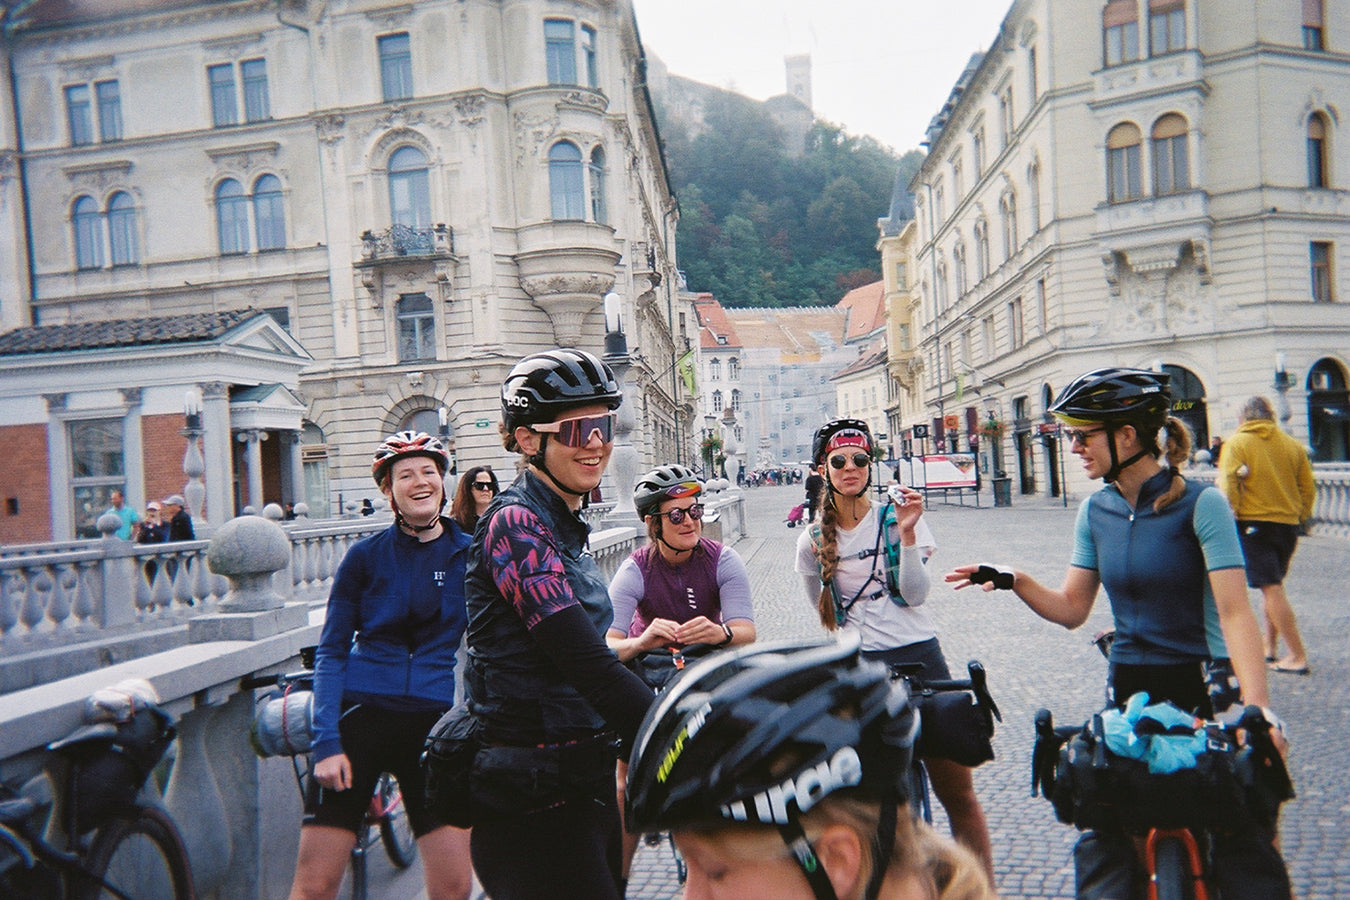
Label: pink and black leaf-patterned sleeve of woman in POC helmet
xmin=483 ymin=505 xmax=578 ymax=629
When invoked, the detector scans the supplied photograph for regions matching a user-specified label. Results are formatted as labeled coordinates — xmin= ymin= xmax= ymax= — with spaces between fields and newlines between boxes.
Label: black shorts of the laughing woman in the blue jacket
xmin=305 ymin=704 xmax=446 ymax=838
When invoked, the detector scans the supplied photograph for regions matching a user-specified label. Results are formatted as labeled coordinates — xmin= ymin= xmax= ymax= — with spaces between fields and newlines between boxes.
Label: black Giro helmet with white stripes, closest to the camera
xmin=626 ymin=630 xmax=918 ymax=834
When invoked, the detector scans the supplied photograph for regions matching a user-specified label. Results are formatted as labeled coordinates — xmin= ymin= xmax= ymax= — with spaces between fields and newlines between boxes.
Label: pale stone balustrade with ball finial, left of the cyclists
xmin=0 ymin=517 xmax=636 ymax=900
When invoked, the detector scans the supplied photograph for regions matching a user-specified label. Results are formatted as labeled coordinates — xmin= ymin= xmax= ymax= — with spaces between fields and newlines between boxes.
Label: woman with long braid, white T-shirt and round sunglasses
xmin=797 ymin=418 xmax=994 ymax=884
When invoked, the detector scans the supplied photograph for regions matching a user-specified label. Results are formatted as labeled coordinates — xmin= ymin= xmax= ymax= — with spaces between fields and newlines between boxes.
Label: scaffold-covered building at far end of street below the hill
xmin=726 ymin=306 xmax=859 ymax=468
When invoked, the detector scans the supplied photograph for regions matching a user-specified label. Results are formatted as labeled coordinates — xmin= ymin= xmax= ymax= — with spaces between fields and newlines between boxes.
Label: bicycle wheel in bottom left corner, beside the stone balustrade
xmin=72 ymin=807 xmax=194 ymax=900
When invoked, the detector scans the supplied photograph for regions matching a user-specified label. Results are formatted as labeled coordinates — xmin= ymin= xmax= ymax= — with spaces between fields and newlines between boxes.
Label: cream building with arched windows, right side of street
xmin=910 ymin=0 xmax=1350 ymax=495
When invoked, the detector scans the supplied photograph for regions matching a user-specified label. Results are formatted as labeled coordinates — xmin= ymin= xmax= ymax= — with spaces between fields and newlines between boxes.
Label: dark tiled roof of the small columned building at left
xmin=0 ymin=309 xmax=263 ymax=356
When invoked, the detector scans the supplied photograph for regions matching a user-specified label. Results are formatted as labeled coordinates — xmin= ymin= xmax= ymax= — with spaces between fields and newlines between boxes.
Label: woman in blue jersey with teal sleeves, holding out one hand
xmin=945 ymin=368 xmax=1289 ymax=900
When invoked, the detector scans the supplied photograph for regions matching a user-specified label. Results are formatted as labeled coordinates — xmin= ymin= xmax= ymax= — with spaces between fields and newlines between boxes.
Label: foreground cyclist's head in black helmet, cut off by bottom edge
xmin=626 ymin=631 xmax=994 ymax=900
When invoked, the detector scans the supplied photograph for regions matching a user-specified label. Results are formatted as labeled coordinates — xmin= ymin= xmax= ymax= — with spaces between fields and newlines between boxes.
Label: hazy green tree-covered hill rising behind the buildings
xmin=653 ymin=77 xmax=923 ymax=306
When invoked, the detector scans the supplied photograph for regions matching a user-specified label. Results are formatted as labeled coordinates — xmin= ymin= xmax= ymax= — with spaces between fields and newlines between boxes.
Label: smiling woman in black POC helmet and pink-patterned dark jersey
xmin=466 ymin=348 xmax=652 ymax=900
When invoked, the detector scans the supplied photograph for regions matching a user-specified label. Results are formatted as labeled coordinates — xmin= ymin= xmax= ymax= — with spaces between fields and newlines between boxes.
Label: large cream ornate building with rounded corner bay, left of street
xmin=0 ymin=0 xmax=685 ymax=540
